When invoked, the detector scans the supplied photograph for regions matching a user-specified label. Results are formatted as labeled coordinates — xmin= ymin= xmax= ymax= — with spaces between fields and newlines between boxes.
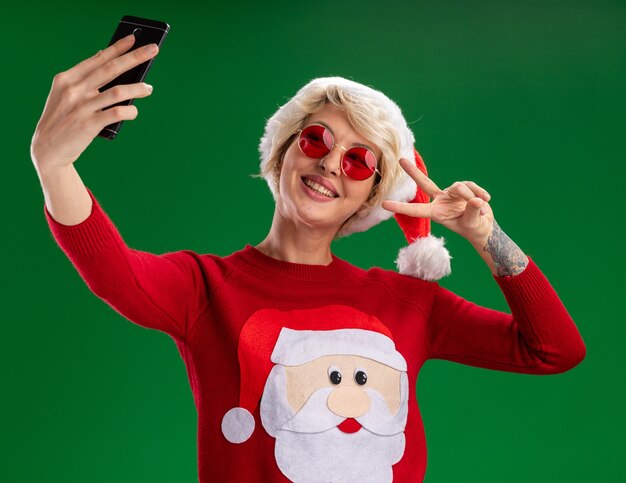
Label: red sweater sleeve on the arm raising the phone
xmin=44 ymin=188 xmax=208 ymax=340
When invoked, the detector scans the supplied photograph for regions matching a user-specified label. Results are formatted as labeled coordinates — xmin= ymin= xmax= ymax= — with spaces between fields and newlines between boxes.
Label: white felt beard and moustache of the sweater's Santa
xmin=261 ymin=365 xmax=408 ymax=483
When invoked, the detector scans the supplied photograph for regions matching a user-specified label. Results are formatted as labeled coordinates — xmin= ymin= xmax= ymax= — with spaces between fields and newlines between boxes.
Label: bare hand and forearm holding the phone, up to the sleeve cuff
xmin=30 ymin=35 xmax=158 ymax=206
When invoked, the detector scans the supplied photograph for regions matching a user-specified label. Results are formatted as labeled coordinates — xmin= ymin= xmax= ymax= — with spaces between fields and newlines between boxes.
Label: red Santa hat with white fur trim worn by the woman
xmin=259 ymin=77 xmax=451 ymax=281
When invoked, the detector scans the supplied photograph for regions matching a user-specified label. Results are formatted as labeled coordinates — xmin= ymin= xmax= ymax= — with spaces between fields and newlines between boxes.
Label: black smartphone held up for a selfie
xmin=98 ymin=15 xmax=170 ymax=139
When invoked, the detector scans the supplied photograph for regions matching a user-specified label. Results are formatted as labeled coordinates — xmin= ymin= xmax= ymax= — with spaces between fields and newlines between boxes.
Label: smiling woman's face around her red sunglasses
xmin=276 ymin=104 xmax=381 ymax=233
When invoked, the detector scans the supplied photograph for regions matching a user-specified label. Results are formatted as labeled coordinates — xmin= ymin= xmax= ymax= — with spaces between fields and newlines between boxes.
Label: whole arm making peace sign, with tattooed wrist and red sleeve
xmin=383 ymin=159 xmax=586 ymax=374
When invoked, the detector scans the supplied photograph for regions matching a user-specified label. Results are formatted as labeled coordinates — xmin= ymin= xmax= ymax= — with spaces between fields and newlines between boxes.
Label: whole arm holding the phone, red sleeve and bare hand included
xmin=30 ymin=35 xmax=209 ymax=339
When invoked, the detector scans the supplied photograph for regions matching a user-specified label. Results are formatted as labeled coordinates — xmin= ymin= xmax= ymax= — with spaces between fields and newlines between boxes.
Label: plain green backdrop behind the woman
xmin=0 ymin=0 xmax=626 ymax=483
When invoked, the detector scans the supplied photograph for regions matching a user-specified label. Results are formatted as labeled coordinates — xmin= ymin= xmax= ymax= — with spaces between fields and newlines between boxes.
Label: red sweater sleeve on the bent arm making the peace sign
xmin=428 ymin=257 xmax=586 ymax=374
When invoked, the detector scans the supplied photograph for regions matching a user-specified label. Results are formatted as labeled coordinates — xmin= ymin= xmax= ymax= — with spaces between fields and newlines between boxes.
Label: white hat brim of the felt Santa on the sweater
xmin=271 ymin=327 xmax=406 ymax=371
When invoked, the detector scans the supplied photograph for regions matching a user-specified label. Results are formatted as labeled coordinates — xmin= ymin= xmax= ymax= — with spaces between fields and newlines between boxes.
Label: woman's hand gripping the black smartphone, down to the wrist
xmin=31 ymin=17 xmax=167 ymax=175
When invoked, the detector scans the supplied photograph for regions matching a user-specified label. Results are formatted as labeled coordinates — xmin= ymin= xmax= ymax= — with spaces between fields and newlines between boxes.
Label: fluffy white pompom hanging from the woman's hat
xmin=396 ymin=235 xmax=452 ymax=282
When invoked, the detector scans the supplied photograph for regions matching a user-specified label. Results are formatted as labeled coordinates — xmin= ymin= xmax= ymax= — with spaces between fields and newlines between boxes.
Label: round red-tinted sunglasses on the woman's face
xmin=298 ymin=124 xmax=381 ymax=181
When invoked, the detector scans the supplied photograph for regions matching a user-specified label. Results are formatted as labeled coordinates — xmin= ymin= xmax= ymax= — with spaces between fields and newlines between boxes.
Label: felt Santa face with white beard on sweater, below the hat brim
xmin=261 ymin=346 xmax=408 ymax=482
